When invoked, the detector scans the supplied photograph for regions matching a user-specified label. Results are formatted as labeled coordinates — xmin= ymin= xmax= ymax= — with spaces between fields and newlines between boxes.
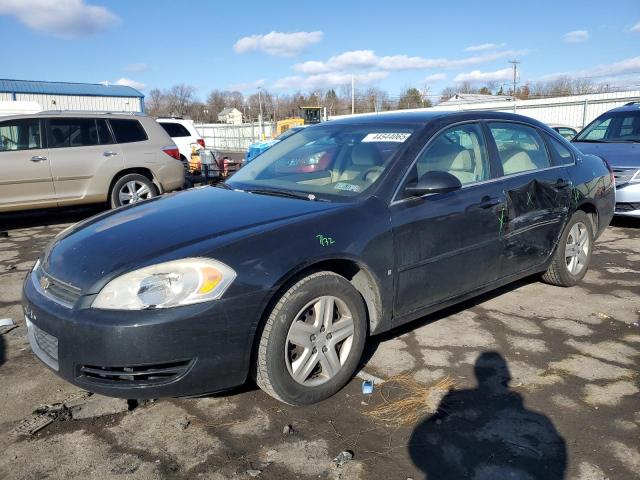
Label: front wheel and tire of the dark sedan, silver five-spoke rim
xmin=255 ymin=272 xmax=367 ymax=405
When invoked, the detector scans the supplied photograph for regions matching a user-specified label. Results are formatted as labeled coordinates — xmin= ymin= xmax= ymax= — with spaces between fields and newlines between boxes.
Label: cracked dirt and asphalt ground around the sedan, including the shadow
xmin=0 ymin=209 xmax=640 ymax=480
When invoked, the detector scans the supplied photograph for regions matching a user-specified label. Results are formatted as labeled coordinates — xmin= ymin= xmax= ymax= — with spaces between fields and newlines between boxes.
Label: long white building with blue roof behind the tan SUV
xmin=0 ymin=79 xmax=144 ymax=112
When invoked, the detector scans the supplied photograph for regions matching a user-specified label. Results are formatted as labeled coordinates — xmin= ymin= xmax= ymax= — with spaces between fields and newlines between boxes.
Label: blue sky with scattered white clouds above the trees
xmin=0 ymin=0 xmax=640 ymax=99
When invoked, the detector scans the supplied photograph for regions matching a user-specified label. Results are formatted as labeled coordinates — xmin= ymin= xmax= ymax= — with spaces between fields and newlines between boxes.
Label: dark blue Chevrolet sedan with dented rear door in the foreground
xmin=23 ymin=111 xmax=614 ymax=405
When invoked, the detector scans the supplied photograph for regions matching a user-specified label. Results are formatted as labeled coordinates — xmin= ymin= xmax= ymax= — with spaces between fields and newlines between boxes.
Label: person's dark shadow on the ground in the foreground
xmin=409 ymin=352 xmax=567 ymax=480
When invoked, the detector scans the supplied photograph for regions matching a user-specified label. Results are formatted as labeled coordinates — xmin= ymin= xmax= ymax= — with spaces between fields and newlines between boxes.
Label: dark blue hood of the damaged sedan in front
xmin=43 ymin=187 xmax=340 ymax=294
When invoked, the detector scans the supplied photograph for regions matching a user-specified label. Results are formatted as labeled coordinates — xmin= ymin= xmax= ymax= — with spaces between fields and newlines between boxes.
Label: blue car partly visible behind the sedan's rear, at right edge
xmin=573 ymin=102 xmax=640 ymax=218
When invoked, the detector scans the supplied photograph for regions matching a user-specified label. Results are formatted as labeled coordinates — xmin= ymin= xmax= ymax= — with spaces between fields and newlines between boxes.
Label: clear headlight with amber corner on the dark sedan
xmin=91 ymin=258 xmax=236 ymax=310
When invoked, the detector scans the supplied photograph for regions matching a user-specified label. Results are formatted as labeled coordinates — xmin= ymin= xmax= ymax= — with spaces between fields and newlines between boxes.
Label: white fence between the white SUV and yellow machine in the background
xmin=195 ymin=122 xmax=276 ymax=152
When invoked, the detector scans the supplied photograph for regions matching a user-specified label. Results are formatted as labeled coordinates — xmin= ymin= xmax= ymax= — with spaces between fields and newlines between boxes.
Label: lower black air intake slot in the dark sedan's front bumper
xmin=78 ymin=360 xmax=192 ymax=387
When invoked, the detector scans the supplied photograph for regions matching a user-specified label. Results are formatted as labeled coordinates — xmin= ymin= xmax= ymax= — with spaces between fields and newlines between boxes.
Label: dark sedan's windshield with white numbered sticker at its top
xmin=227 ymin=124 xmax=413 ymax=200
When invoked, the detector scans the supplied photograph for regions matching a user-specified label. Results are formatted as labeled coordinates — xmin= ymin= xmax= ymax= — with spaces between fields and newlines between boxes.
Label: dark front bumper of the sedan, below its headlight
xmin=23 ymin=275 xmax=260 ymax=399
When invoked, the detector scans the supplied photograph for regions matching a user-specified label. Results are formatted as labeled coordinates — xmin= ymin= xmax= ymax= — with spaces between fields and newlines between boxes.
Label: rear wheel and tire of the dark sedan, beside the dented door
xmin=542 ymin=210 xmax=593 ymax=287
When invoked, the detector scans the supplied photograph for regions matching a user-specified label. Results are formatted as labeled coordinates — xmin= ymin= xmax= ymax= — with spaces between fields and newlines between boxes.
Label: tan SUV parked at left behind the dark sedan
xmin=0 ymin=112 xmax=184 ymax=212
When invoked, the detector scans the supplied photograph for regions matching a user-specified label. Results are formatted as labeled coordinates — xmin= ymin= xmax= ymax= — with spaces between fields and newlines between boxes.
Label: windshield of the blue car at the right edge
xmin=574 ymin=110 xmax=640 ymax=143
